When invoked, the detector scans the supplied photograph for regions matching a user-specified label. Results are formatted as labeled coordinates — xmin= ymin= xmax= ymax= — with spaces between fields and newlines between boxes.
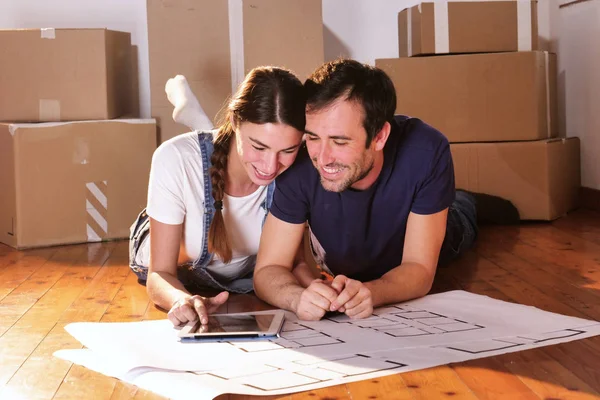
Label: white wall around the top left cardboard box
xmin=0 ymin=0 xmax=150 ymax=118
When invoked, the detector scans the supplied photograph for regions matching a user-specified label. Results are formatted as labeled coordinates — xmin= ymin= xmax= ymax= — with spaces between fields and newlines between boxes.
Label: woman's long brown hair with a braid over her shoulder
xmin=208 ymin=67 xmax=306 ymax=263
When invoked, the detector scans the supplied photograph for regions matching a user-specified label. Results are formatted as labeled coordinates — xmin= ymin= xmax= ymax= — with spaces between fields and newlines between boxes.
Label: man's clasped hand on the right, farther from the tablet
xmin=328 ymin=275 xmax=373 ymax=319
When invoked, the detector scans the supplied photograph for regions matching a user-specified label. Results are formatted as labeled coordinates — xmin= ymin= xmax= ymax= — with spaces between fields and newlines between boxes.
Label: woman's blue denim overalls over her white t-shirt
xmin=129 ymin=132 xmax=275 ymax=293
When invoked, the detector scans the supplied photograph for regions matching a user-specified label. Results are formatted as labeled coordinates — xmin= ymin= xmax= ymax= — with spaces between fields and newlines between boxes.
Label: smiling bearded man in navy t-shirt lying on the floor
xmin=254 ymin=60 xmax=518 ymax=320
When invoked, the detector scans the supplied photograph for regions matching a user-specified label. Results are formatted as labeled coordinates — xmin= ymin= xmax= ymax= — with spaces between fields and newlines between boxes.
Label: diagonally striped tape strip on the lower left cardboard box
xmin=85 ymin=181 xmax=108 ymax=242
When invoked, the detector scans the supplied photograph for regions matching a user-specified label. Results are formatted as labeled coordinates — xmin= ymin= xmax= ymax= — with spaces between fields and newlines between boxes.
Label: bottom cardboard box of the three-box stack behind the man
xmin=450 ymin=138 xmax=581 ymax=220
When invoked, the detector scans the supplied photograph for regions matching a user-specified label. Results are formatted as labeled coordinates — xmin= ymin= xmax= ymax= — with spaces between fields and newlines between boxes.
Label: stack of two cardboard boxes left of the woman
xmin=0 ymin=29 xmax=156 ymax=249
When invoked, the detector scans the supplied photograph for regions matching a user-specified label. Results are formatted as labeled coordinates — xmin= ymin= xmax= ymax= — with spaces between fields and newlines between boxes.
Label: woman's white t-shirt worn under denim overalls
xmin=137 ymin=132 xmax=267 ymax=281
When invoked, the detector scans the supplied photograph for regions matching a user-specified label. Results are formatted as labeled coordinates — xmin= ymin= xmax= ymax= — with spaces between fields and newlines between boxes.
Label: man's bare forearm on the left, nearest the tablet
xmin=254 ymin=265 xmax=304 ymax=312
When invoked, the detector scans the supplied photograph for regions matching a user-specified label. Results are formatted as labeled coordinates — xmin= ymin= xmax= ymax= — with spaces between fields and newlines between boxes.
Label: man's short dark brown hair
xmin=304 ymin=59 xmax=396 ymax=147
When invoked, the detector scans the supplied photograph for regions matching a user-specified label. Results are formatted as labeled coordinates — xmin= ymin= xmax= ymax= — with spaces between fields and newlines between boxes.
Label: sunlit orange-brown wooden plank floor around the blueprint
xmin=0 ymin=210 xmax=600 ymax=400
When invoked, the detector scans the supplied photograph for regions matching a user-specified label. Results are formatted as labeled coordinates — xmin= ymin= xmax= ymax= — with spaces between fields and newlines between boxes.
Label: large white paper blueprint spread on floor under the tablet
xmin=55 ymin=291 xmax=600 ymax=399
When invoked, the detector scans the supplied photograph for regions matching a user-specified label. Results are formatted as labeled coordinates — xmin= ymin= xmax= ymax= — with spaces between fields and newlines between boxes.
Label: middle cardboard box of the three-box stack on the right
xmin=376 ymin=51 xmax=558 ymax=142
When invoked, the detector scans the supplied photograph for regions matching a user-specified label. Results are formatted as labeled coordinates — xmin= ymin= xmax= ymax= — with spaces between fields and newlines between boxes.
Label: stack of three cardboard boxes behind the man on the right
xmin=376 ymin=0 xmax=580 ymax=220
